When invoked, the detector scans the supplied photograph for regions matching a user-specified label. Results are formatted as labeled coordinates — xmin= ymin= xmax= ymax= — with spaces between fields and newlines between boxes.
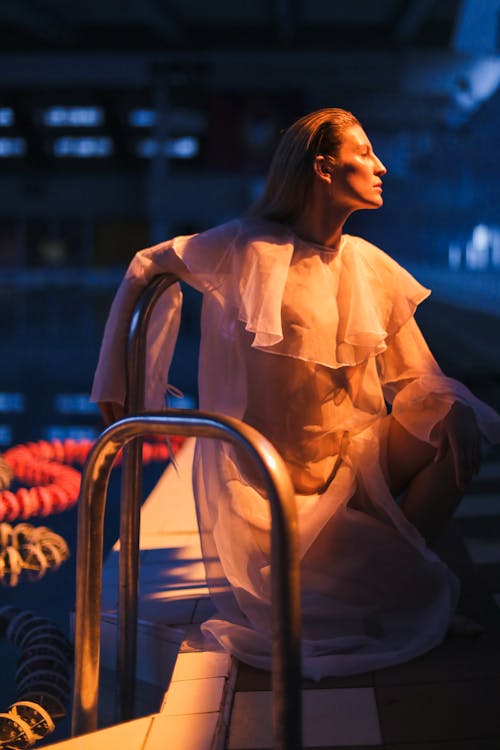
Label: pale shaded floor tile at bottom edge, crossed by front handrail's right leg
xmin=228 ymin=688 xmax=382 ymax=750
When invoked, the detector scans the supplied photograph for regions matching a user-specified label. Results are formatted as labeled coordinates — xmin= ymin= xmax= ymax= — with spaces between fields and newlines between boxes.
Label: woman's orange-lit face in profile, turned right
xmin=331 ymin=125 xmax=387 ymax=212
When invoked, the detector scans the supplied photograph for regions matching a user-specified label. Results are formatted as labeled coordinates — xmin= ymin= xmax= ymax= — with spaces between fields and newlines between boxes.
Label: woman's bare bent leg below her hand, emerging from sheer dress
xmin=387 ymin=417 xmax=463 ymax=546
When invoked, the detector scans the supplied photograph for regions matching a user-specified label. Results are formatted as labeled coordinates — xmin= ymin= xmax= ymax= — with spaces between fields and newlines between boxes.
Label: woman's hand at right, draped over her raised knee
xmin=434 ymin=401 xmax=482 ymax=492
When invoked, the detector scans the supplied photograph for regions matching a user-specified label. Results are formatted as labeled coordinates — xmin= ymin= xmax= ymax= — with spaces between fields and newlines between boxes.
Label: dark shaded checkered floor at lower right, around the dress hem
xmin=227 ymin=450 xmax=500 ymax=750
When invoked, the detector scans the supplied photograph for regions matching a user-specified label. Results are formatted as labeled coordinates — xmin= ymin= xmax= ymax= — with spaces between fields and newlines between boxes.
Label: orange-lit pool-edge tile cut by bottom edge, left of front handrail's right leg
xmin=144 ymin=713 xmax=219 ymax=750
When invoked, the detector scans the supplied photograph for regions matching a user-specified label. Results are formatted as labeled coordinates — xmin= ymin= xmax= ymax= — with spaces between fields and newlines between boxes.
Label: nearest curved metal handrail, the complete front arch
xmin=72 ymin=409 xmax=302 ymax=750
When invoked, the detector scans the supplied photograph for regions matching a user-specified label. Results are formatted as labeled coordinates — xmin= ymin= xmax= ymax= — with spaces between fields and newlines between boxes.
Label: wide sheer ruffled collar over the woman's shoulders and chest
xmin=232 ymin=219 xmax=430 ymax=368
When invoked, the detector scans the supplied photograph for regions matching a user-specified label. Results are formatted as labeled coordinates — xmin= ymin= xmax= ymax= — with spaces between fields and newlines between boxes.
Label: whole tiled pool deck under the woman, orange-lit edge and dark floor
xmin=45 ymin=441 xmax=500 ymax=750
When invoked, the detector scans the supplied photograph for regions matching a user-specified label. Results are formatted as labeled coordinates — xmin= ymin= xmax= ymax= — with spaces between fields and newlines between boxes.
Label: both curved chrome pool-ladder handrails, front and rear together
xmin=72 ymin=277 xmax=302 ymax=750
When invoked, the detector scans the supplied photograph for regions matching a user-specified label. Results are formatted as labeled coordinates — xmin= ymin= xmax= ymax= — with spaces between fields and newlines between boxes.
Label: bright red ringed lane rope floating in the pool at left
xmin=0 ymin=436 xmax=184 ymax=522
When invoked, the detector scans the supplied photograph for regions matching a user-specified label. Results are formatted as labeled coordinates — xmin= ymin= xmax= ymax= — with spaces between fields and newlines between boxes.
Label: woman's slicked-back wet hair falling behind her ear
xmin=248 ymin=107 xmax=360 ymax=223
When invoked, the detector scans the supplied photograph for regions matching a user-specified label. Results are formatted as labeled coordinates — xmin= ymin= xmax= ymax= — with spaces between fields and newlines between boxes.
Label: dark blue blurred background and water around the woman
xmin=0 ymin=0 xmax=500 ymax=740
